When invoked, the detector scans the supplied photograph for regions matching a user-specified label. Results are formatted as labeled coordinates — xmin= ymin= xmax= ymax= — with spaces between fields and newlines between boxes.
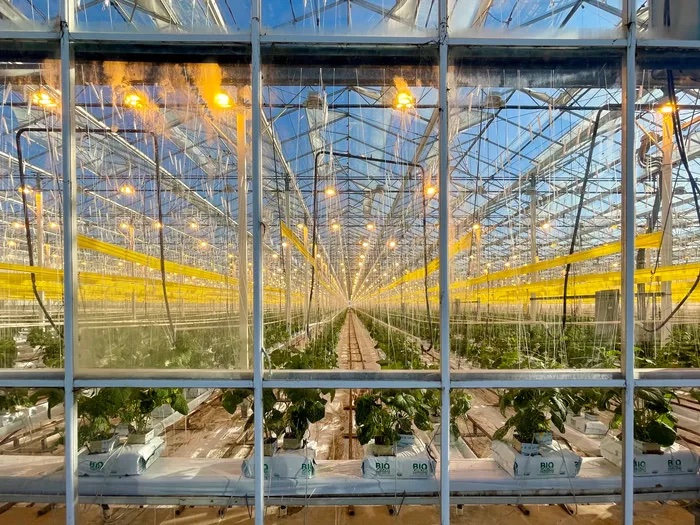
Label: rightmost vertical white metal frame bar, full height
xmin=621 ymin=0 xmax=637 ymax=525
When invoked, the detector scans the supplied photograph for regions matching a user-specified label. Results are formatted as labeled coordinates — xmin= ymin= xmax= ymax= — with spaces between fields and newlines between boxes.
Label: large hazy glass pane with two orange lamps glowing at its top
xmin=76 ymin=57 xmax=252 ymax=369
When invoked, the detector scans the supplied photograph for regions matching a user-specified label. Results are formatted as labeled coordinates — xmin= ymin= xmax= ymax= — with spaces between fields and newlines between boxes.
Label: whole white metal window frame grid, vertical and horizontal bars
xmin=0 ymin=0 xmax=700 ymax=525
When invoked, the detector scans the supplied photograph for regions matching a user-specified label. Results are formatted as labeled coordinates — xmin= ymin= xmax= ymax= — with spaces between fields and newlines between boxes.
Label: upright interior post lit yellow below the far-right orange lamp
xmin=659 ymin=113 xmax=673 ymax=345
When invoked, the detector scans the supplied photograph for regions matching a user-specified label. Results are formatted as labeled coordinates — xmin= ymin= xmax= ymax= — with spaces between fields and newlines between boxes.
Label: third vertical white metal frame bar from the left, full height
xmin=438 ymin=0 xmax=450 ymax=525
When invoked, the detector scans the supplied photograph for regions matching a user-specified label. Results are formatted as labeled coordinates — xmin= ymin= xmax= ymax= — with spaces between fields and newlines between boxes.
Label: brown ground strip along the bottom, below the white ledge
xmin=0 ymin=503 xmax=695 ymax=525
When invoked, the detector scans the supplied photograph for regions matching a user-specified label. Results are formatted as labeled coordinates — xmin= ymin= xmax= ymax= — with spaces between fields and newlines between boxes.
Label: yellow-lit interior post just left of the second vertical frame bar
xmin=236 ymin=111 xmax=251 ymax=368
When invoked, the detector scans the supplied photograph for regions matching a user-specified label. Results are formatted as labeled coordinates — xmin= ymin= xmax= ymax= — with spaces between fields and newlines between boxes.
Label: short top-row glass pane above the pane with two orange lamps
xmin=75 ymin=0 xmax=251 ymax=34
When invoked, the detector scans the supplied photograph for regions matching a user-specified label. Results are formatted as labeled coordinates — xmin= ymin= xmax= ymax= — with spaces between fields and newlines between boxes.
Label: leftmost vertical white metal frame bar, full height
xmin=60 ymin=0 xmax=78 ymax=525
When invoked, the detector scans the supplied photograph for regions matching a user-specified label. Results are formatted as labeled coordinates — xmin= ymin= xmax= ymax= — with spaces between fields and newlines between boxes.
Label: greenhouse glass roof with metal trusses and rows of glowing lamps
xmin=0 ymin=0 xmax=700 ymax=298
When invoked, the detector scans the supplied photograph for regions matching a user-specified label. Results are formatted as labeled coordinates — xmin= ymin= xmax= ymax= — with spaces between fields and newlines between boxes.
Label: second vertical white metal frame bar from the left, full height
xmin=250 ymin=0 xmax=265 ymax=525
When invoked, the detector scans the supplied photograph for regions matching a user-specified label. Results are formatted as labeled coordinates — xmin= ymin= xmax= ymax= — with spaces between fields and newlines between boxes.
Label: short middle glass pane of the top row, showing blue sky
xmin=262 ymin=0 xmax=438 ymax=36
